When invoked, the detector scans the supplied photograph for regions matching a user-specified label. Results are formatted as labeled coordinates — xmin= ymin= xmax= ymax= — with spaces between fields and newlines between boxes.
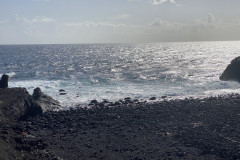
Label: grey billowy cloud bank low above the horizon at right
xmin=145 ymin=14 xmax=240 ymax=41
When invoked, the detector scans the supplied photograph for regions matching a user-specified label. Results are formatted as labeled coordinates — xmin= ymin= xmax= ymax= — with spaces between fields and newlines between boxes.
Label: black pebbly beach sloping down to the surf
xmin=15 ymin=95 xmax=240 ymax=160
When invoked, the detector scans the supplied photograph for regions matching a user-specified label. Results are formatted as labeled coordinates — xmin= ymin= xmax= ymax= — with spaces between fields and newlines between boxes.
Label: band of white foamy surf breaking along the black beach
xmin=9 ymin=80 xmax=240 ymax=107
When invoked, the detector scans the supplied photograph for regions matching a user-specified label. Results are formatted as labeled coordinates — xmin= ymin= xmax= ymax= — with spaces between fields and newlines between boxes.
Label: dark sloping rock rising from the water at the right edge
xmin=219 ymin=56 xmax=240 ymax=82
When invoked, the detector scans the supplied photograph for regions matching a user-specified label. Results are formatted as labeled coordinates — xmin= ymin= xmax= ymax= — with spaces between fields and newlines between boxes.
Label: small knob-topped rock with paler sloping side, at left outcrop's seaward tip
xmin=33 ymin=87 xmax=60 ymax=112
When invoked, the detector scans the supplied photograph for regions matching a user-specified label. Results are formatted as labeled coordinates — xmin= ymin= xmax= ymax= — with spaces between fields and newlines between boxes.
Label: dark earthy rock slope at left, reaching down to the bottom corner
xmin=0 ymin=88 xmax=58 ymax=160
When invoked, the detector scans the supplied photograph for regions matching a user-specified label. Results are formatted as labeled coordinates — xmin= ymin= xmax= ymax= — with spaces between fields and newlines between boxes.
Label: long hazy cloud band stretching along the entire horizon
xmin=3 ymin=11 xmax=240 ymax=43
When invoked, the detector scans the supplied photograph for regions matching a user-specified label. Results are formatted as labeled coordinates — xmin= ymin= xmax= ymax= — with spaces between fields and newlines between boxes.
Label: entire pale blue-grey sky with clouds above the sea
xmin=0 ymin=0 xmax=240 ymax=44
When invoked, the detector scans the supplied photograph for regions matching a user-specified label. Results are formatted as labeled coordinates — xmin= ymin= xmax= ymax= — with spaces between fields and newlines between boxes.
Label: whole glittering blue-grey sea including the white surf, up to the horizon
xmin=0 ymin=41 xmax=240 ymax=107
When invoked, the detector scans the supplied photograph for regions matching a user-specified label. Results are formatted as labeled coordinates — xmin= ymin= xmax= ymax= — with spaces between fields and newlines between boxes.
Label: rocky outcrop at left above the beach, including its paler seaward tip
xmin=0 ymin=88 xmax=60 ymax=122
